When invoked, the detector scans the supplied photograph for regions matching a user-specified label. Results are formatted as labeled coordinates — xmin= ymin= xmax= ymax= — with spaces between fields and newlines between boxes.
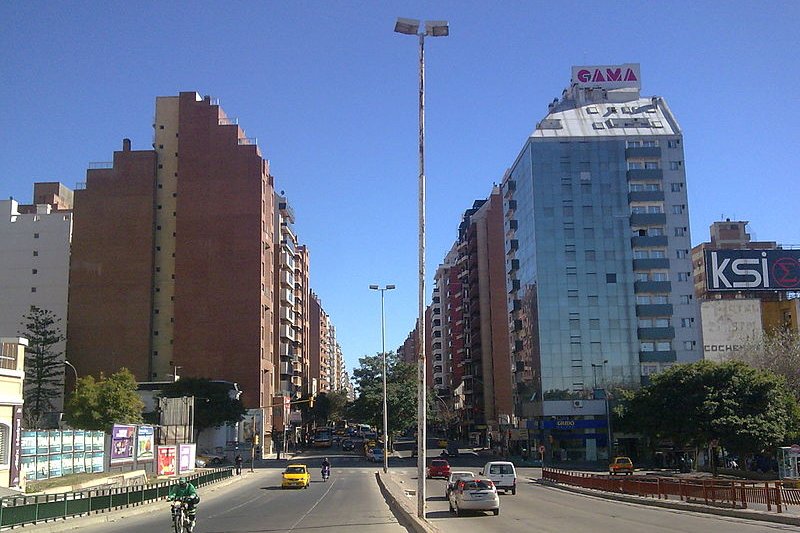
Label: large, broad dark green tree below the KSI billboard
xmin=620 ymin=361 xmax=800 ymax=454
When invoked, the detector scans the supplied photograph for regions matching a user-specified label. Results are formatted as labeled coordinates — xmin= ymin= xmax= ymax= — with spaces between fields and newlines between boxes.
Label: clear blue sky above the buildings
xmin=0 ymin=1 xmax=800 ymax=374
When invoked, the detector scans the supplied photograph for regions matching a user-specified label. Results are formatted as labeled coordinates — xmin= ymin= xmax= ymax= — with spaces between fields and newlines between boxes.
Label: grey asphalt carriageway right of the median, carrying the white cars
xmin=396 ymin=465 xmax=797 ymax=533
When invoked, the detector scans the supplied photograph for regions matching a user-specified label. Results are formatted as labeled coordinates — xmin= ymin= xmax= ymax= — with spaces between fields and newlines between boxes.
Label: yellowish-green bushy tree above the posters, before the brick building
xmin=64 ymin=367 xmax=144 ymax=431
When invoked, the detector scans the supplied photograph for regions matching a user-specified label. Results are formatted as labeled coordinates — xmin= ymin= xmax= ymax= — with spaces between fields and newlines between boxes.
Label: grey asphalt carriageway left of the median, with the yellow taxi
xmin=51 ymin=451 xmax=406 ymax=533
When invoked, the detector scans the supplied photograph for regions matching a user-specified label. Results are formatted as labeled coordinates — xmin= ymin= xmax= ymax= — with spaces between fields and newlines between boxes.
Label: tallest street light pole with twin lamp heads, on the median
xmin=394 ymin=18 xmax=450 ymax=519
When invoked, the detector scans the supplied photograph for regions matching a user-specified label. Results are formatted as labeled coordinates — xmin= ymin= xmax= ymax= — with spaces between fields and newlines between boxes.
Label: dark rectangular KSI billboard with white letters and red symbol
xmin=706 ymin=250 xmax=800 ymax=291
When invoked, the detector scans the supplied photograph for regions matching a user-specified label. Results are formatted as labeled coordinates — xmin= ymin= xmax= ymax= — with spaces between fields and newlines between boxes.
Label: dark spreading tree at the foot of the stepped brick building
xmin=161 ymin=378 xmax=242 ymax=441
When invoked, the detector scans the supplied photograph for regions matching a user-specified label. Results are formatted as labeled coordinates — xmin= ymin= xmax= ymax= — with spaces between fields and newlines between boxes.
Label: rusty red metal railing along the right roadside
xmin=542 ymin=468 xmax=800 ymax=513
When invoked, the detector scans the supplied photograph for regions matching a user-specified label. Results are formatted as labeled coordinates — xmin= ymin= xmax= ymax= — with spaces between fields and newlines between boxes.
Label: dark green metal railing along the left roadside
xmin=0 ymin=468 xmax=232 ymax=529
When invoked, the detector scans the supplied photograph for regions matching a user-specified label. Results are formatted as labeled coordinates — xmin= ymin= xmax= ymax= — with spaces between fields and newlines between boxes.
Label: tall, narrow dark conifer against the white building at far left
xmin=20 ymin=306 xmax=64 ymax=429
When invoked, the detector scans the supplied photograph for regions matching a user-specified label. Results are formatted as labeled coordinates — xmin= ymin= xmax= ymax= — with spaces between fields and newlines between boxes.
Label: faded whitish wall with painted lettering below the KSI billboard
xmin=700 ymin=298 xmax=762 ymax=362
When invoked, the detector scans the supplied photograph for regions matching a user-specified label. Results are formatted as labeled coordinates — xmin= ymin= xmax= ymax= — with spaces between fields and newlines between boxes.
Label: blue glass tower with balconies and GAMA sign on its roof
xmin=502 ymin=64 xmax=702 ymax=459
